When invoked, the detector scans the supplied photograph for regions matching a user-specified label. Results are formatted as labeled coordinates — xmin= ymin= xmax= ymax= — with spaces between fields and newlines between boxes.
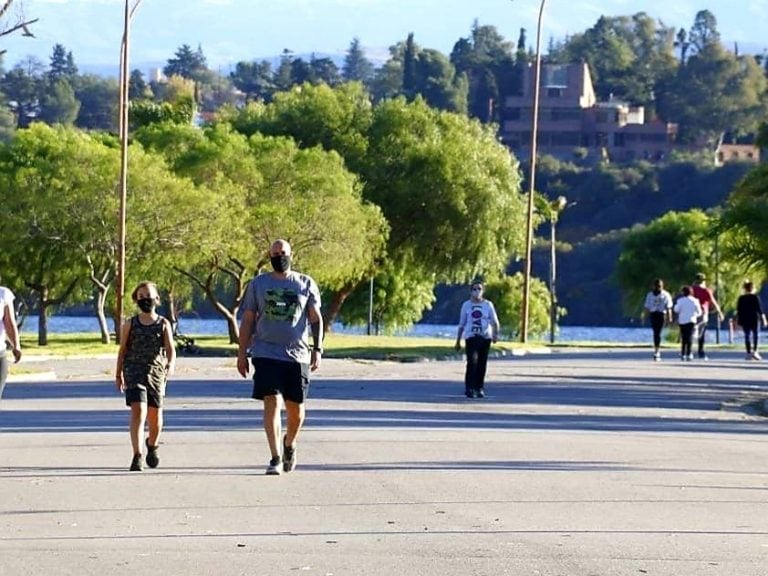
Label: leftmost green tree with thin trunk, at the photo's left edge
xmin=0 ymin=124 xmax=89 ymax=346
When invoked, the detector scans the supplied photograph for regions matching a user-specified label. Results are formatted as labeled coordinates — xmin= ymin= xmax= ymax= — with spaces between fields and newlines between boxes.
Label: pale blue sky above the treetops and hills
xmin=0 ymin=0 xmax=768 ymax=69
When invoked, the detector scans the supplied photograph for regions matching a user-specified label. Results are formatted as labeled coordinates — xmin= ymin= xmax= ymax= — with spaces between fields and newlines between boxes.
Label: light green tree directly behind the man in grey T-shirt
xmin=136 ymin=124 xmax=386 ymax=341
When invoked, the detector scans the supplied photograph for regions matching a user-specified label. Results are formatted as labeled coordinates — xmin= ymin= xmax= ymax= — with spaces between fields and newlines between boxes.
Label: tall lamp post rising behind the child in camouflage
xmin=115 ymin=0 xmax=141 ymax=342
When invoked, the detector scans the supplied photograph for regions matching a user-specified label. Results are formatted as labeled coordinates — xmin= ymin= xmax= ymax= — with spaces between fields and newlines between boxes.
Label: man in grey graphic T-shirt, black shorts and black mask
xmin=237 ymin=240 xmax=323 ymax=475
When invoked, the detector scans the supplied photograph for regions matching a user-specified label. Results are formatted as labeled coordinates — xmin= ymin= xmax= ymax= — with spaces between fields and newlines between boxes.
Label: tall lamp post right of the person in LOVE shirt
xmin=520 ymin=0 xmax=546 ymax=343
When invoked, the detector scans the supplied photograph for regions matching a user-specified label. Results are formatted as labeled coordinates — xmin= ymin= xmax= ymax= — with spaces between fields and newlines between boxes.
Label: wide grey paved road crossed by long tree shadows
xmin=0 ymin=350 xmax=768 ymax=576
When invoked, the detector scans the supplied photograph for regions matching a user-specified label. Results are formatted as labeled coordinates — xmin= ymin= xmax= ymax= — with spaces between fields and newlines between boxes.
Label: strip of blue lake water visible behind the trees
xmin=16 ymin=316 xmax=728 ymax=344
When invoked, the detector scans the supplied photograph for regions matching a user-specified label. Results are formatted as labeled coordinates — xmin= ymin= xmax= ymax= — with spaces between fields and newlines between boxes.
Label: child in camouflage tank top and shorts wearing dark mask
xmin=115 ymin=281 xmax=176 ymax=472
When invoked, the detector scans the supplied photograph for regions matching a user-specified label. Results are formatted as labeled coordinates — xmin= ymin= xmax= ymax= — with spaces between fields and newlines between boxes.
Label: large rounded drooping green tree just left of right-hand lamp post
xmin=356 ymin=99 xmax=524 ymax=324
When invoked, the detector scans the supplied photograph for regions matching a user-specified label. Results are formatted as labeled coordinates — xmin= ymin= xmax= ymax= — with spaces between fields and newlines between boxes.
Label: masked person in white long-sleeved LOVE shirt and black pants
xmin=456 ymin=282 xmax=500 ymax=398
